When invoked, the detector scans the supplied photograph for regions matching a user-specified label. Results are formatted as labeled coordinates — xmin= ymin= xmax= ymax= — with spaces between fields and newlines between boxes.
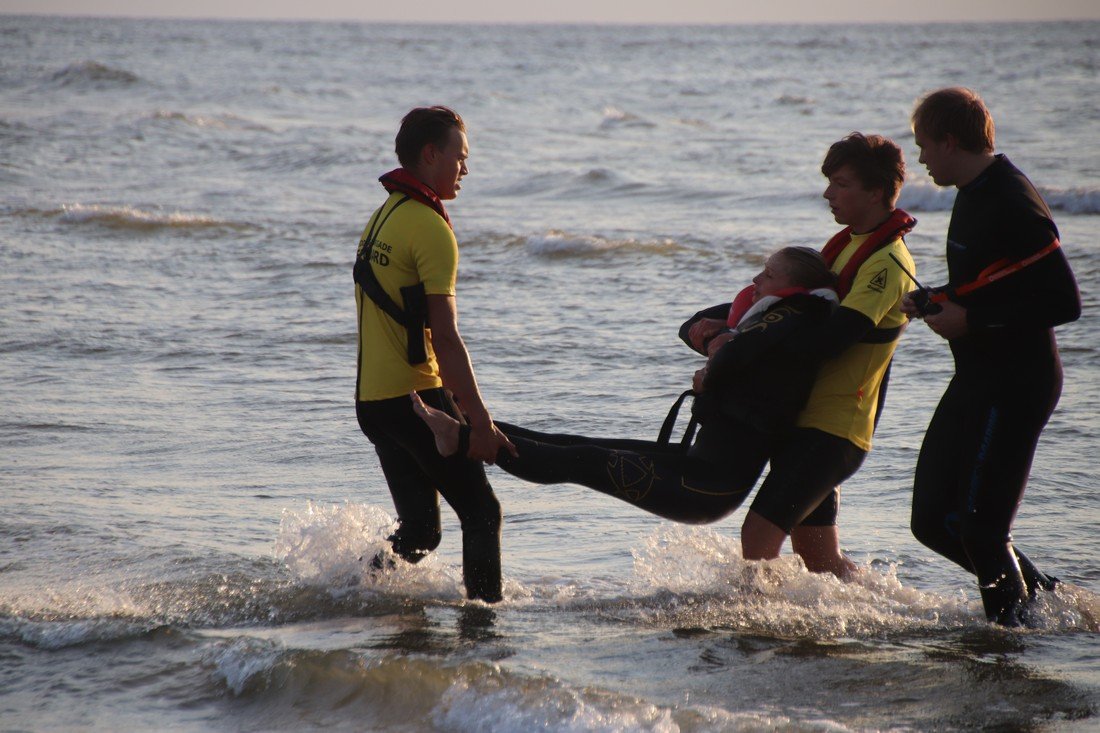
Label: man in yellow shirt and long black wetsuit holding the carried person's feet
xmin=355 ymin=107 xmax=515 ymax=603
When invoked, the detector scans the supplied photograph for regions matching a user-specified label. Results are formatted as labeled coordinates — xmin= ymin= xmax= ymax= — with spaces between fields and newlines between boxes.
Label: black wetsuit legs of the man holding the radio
xmin=912 ymin=376 xmax=1060 ymax=625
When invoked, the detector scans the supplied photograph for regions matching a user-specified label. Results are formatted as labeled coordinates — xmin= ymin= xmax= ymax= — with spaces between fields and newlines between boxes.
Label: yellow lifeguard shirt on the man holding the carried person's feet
xmin=355 ymin=193 xmax=459 ymax=401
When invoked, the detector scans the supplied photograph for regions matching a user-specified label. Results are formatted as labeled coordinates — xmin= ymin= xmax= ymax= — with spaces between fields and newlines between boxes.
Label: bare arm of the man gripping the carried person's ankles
xmin=428 ymin=295 xmax=516 ymax=463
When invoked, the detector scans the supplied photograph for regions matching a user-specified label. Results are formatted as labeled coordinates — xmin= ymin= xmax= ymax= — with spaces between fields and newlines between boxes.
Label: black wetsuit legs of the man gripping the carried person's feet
xmin=355 ymin=390 xmax=502 ymax=602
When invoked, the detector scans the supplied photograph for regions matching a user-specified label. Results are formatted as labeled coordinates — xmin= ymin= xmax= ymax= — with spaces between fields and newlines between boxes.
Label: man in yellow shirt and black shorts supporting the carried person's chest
xmin=741 ymin=132 xmax=916 ymax=577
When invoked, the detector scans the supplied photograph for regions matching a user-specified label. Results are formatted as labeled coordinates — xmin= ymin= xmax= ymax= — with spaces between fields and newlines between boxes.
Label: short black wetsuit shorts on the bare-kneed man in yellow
xmin=750 ymin=428 xmax=867 ymax=534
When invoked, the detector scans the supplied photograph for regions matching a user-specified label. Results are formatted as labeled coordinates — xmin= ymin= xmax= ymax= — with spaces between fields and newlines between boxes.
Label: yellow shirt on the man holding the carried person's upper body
xmin=795 ymin=233 xmax=915 ymax=450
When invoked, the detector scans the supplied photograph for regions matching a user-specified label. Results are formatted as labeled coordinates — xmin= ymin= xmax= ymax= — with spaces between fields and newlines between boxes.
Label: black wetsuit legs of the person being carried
xmin=497 ymin=424 xmax=770 ymax=524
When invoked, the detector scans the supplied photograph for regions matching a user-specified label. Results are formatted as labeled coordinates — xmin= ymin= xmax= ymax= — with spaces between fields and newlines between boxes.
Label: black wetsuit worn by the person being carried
xmin=497 ymin=294 xmax=832 ymax=524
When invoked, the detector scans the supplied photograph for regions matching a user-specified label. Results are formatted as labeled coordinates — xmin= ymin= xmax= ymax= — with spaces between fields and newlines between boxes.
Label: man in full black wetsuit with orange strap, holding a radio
xmin=902 ymin=88 xmax=1081 ymax=626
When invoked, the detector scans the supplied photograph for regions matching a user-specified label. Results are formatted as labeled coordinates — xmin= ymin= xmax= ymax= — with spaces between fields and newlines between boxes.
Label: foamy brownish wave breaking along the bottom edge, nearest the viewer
xmin=202 ymin=636 xmax=814 ymax=733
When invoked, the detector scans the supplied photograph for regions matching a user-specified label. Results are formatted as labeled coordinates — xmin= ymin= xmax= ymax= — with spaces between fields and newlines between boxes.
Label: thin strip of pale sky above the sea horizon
xmin=0 ymin=0 xmax=1100 ymax=23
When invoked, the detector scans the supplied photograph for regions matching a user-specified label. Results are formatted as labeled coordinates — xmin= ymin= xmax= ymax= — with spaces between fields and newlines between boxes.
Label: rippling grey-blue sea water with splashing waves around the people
xmin=0 ymin=17 xmax=1100 ymax=731
